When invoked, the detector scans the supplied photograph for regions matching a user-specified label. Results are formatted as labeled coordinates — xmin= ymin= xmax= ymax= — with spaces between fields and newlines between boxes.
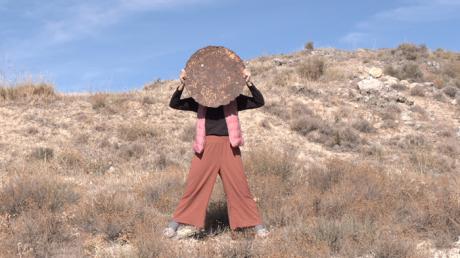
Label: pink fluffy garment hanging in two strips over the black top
xmin=193 ymin=100 xmax=244 ymax=153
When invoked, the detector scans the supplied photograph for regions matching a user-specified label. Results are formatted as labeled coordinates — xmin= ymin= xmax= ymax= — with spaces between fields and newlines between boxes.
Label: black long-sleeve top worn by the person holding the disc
xmin=169 ymin=84 xmax=265 ymax=136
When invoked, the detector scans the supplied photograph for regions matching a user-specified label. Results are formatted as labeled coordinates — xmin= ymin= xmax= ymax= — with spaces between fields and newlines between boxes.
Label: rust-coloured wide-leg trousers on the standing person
xmin=173 ymin=135 xmax=262 ymax=230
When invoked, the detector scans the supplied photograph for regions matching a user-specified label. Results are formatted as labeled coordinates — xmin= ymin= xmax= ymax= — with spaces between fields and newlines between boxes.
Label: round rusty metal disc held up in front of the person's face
xmin=185 ymin=46 xmax=246 ymax=107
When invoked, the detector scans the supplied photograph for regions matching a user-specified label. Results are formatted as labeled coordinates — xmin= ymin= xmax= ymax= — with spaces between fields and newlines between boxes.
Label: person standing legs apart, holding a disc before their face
xmin=163 ymin=69 xmax=269 ymax=238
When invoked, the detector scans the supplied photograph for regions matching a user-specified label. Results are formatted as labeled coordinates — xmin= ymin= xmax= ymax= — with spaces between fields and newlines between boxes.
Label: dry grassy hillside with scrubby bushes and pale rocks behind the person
xmin=0 ymin=44 xmax=460 ymax=257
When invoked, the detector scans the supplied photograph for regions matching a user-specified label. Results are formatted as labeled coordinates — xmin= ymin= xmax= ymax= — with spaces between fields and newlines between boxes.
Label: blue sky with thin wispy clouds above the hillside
xmin=0 ymin=0 xmax=460 ymax=92
